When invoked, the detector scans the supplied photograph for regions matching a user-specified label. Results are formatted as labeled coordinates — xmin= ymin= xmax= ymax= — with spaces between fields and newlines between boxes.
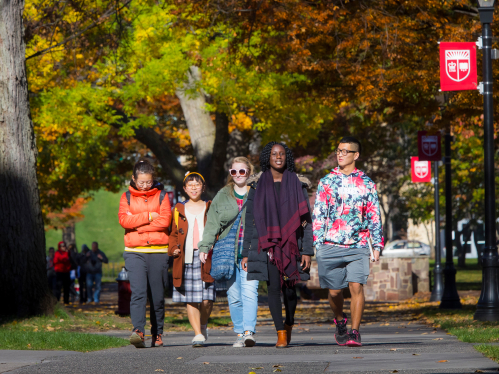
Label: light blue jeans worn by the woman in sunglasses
xmin=227 ymin=260 xmax=258 ymax=334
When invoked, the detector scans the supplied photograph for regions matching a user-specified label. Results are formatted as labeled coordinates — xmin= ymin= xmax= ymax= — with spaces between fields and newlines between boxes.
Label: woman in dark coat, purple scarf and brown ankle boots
xmin=241 ymin=142 xmax=314 ymax=348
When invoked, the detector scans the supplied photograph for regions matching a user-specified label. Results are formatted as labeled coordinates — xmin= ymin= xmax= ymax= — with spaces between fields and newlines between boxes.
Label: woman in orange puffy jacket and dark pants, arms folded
xmin=118 ymin=161 xmax=171 ymax=348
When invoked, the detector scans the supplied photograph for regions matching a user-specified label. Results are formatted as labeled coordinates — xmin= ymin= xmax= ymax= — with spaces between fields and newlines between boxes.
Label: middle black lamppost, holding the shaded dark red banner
xmin=440 ymin=134 xmax=461 ymax=309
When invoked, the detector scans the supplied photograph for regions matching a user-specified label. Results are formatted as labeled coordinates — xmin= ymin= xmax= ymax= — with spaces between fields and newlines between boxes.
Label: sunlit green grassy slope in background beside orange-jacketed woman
xmin=45 ymin=188 xmax=125 ymax=261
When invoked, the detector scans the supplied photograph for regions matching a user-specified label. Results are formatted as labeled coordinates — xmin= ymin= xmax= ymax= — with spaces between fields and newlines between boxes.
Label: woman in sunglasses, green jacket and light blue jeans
xmin=199 ymin=157 xmax=258 ymax=348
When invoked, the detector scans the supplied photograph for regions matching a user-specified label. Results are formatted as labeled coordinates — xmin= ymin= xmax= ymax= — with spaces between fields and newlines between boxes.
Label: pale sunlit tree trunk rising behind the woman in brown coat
xmin=176 ymin=66 xmax=216 ymax=175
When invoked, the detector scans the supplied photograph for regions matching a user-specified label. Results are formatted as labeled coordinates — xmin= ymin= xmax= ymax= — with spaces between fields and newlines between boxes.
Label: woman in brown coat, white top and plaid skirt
xmin=168 ymin=173 xmax=216 ymax=347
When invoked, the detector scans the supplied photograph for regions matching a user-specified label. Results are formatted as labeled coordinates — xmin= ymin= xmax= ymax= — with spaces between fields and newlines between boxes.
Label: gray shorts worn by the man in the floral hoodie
xmin=316 ymin=244 xmax=369 ymax=290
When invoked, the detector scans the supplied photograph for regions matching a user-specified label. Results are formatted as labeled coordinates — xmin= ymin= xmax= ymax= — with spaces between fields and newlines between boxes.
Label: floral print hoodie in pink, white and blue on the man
xmin=313 ymin=167 xmax=384 ymax=251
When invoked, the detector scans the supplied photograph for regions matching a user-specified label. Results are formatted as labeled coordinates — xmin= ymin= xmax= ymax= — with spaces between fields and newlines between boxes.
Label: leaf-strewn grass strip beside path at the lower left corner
xmin=0 ymin=305 xmax=130 ymax=352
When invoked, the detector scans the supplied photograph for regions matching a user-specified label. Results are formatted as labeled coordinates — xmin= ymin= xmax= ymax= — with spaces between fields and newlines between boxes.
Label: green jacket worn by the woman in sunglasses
xmin=198 ymin=186 xmax=248 ymax=263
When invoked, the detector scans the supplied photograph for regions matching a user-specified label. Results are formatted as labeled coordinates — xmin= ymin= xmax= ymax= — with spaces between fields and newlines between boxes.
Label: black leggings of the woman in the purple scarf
xmin=267 ymin=260 xmax=298 ymax=331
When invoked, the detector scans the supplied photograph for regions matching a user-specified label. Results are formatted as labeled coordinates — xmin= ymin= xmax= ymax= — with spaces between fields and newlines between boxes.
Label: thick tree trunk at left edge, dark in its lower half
xmin=0 ymin=0 xmax=52 ymax=317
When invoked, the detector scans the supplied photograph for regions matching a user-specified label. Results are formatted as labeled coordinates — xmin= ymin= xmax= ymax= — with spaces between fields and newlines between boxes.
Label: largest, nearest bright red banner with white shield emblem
xmin=440 ymin=42 xmax=477 ymax=91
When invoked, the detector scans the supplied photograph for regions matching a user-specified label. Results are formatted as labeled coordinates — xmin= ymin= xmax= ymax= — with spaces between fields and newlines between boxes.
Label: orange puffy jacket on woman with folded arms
xmin=118 ymin=183 xmax=172 ymax=248
